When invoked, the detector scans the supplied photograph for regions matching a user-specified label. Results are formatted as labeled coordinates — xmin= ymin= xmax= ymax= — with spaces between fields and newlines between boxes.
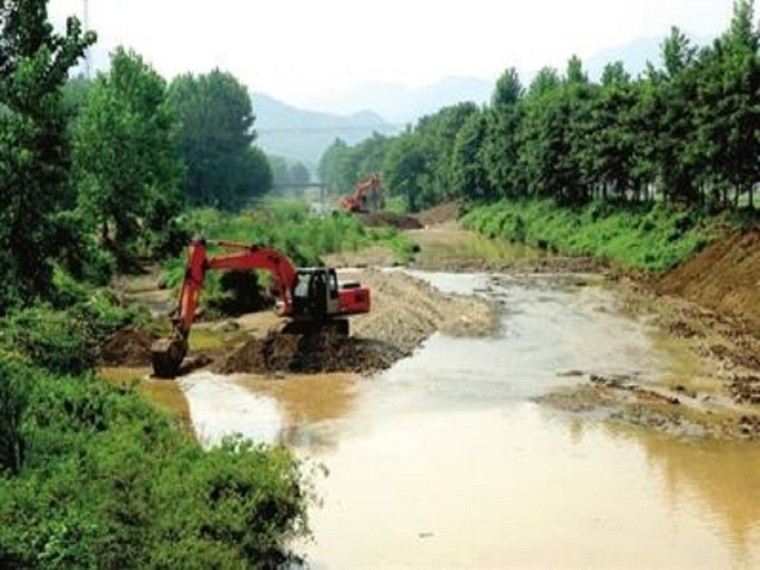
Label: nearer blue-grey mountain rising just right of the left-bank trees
xmin=251 ymin=92 xmax=399 ymax=171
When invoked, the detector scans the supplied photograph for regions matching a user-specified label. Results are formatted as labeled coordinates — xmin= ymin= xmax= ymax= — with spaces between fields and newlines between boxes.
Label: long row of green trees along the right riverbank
xmin=319 ymin=0 xmax=760 ymax=211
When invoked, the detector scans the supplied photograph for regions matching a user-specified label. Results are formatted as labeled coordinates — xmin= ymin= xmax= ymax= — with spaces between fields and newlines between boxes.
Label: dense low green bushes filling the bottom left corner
xmin=0 ymin=363 xmax=308 ymax=568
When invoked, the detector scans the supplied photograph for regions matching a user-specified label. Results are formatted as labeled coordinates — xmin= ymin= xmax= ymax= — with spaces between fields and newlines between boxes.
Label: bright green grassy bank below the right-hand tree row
xmin=463 ymin=200 xmax=723 ymax=274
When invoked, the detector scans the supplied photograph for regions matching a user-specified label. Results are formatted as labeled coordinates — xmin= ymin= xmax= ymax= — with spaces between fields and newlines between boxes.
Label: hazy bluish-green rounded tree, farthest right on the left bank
xmin=169 ymin=69 xmax=272 ymax=210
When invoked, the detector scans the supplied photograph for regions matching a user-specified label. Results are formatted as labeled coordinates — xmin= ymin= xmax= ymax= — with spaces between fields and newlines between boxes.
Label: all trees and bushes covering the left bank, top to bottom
xmin=0 ymin=0 xmax=309 ymax=568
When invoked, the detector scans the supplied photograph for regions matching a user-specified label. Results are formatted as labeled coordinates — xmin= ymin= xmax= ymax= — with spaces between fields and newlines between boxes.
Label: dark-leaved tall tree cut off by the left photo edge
xmin=0 ymin=0 xmax=95 ymax=314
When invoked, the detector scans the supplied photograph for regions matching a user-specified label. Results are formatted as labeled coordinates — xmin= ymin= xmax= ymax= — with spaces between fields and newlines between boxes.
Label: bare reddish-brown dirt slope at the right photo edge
xmin=657 ymin=229 xmax=760 ymax=328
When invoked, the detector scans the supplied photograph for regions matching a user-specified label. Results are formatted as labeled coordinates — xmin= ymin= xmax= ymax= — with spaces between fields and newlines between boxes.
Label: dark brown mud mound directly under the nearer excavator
xmin=215 ymin=331 xmax=400 ymax=374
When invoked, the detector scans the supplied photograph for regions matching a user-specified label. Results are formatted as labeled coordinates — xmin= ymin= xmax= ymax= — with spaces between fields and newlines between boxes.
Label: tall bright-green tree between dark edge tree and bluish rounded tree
xmin=74 ymin=48 xmax=183 ymax=265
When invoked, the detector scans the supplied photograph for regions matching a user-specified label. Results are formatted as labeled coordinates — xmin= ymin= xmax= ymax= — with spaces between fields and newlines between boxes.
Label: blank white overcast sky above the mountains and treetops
xmin=49 ymin=0 xmax=733 ymax=107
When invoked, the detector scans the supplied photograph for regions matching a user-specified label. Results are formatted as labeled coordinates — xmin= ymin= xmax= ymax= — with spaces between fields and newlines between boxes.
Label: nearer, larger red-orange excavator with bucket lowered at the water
xmin=151 ymin=239 xmax=370 ymax=378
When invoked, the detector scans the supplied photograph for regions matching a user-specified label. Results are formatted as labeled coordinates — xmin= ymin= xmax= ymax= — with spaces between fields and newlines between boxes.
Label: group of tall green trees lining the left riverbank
xmin=0 ymin=0 xmax=272 ymax=315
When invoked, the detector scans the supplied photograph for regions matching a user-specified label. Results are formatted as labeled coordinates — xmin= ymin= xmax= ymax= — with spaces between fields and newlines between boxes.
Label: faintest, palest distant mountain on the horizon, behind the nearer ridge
xmin=308 ymin=77 xmax=494 ymax=125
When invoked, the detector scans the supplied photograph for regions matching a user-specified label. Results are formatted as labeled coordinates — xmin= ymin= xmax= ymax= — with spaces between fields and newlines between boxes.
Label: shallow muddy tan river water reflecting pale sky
xmin=180 ymin=273 xmax=760 ymax=569
